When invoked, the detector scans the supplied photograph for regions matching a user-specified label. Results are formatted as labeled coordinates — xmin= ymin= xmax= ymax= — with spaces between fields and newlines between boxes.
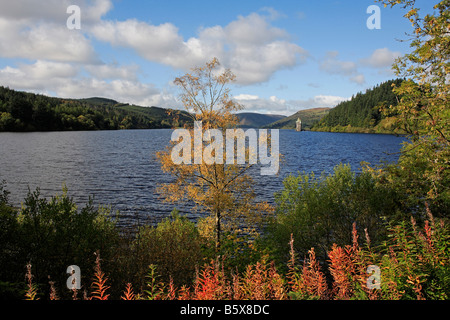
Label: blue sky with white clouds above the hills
xmin=0 ymin=0 xmax=430 ymax=115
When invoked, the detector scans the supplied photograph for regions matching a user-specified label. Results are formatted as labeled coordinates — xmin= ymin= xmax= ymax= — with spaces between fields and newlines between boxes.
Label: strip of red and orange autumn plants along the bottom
xmin=23 ymin=208 xmax=450 ymax=300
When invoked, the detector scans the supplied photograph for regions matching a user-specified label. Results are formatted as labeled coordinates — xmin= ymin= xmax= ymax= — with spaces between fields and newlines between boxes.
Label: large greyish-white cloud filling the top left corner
xmin=0 ymin=0 xmax=112 ymax=63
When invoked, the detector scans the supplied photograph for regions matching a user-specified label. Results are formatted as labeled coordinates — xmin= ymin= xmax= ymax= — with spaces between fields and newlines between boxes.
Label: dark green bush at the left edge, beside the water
xmin=0 ymin=189 xmax=118 ymax=294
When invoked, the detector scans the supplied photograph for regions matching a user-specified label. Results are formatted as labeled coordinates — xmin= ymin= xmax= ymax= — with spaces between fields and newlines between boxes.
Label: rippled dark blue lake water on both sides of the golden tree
xmin=0 ymin=130 xmax=404 ymax=228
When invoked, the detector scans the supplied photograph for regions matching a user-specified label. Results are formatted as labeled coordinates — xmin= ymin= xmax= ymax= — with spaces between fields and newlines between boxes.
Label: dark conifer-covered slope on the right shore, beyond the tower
xmin=313 ymin=79 xmax=403 ymax=132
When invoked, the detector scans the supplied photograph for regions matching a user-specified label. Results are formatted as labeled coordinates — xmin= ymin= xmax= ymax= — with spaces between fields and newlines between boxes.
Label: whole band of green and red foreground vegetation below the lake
xmin=0 ymin=175 xmax=450 ymax=300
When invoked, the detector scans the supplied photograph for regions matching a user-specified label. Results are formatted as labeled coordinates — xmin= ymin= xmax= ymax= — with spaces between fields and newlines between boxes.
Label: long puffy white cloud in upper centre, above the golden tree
xmin=90 ymin=12 xmax=307 ymax=84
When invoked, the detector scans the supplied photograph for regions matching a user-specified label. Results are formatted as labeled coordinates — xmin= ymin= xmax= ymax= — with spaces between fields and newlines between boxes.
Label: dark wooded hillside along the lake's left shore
xmin=0 ymin=86 xmax=188 ymax=131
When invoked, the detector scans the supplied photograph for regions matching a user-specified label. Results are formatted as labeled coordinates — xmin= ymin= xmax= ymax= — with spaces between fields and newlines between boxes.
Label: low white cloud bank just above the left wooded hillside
xmin=0 ymin=60 xmax=172 ymax=107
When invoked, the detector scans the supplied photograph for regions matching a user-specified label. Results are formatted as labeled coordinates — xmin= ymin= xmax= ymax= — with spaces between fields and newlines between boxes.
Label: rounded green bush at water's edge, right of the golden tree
xmin=268 ymin=164 xmax=399 ymax=261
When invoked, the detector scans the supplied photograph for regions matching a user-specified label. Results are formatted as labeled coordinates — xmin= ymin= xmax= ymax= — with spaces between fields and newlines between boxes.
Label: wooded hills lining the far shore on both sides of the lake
xmin=0 ymin=79 xmax=402 ymax=133
